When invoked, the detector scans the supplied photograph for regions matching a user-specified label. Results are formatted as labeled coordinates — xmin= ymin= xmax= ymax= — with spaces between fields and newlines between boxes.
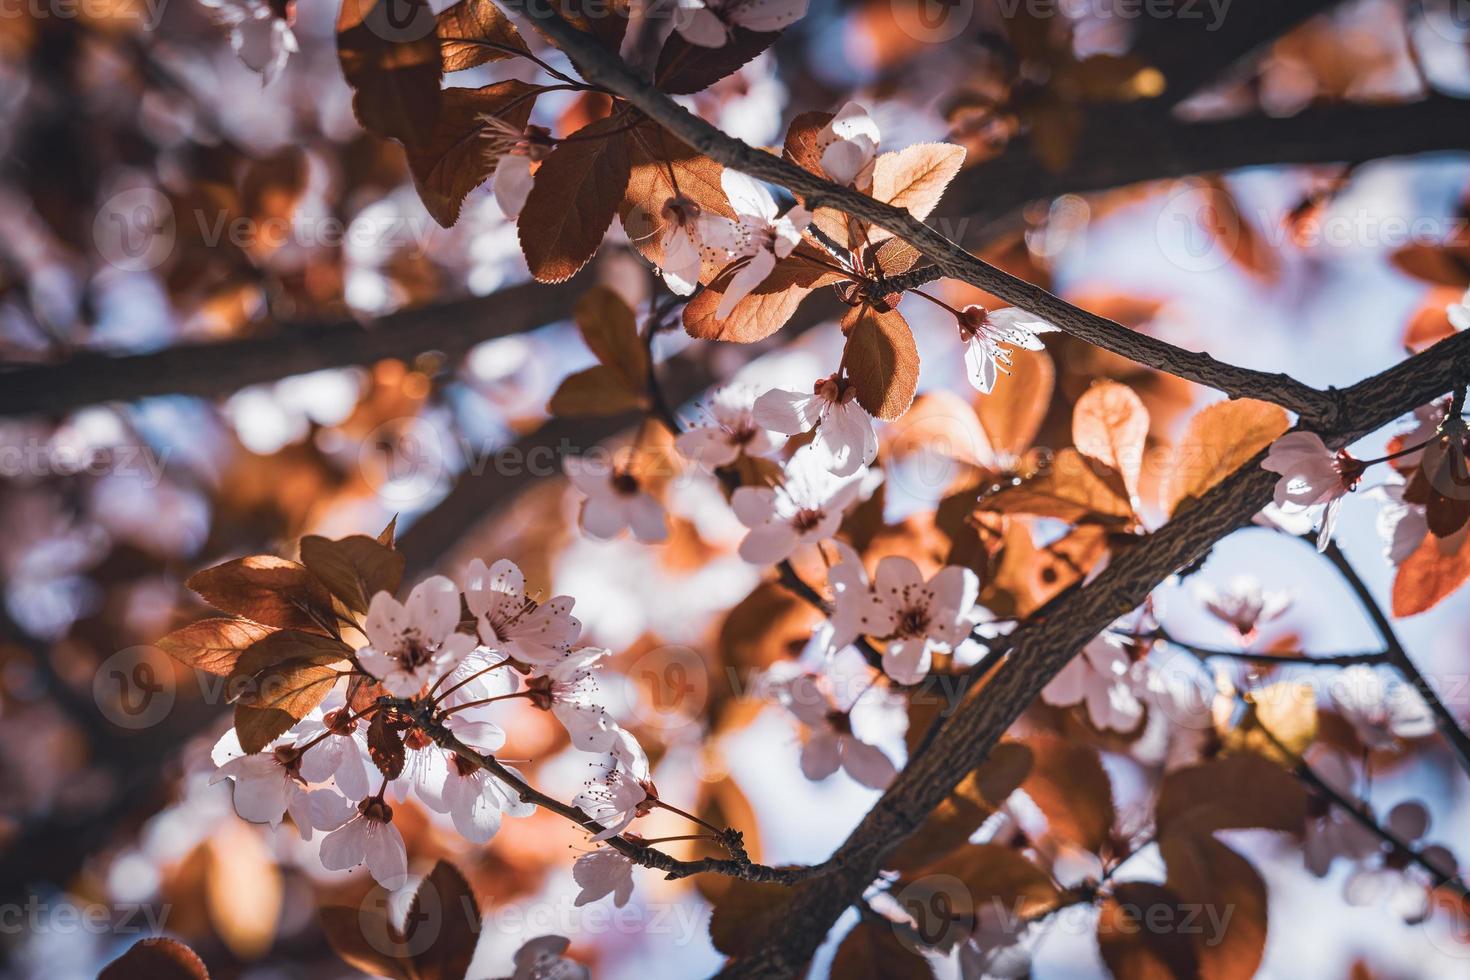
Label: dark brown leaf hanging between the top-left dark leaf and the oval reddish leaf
xmin=405 ymin=82 xmax=537 ymax=228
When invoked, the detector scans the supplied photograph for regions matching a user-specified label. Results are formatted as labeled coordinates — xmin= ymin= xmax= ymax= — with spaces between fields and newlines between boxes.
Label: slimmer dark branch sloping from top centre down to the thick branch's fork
xmin=503 ymin=0 xmax=1338 ymax=428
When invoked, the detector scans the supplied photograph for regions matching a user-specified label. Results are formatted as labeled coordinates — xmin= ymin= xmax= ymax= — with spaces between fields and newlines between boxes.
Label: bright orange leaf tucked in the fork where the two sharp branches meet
xmin=1164 ymin=398 xmax=1291 ymax=514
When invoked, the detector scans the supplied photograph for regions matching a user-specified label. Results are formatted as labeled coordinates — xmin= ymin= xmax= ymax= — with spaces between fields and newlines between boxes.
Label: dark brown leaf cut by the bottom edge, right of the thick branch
xmin=1097 ymin=882 xmax=1200 ymax=980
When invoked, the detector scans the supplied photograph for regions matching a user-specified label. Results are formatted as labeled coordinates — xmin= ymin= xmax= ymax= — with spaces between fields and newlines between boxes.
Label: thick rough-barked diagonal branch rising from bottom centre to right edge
xmin=723 ymin=327 xmax=1470 ymax=977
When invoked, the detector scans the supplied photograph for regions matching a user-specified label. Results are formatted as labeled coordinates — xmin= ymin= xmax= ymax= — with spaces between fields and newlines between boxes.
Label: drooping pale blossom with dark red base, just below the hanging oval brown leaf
xmin=754 ymin=375 xmax=878 ymax=476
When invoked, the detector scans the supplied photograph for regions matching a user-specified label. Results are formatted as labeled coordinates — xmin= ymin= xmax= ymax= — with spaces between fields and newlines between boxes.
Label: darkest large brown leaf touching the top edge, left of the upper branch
xmin=337 ymin=0 xmax=440 ymax=147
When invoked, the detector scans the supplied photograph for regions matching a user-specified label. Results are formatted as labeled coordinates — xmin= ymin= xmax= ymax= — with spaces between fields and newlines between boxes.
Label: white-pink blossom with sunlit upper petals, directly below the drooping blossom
xmin=731 ymin=447 xmax=863 ymax=564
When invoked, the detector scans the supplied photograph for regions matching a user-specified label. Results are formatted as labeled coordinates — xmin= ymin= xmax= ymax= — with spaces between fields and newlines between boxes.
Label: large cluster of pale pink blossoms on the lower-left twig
xmin=213 ymin=560 xmax=653 ymax=901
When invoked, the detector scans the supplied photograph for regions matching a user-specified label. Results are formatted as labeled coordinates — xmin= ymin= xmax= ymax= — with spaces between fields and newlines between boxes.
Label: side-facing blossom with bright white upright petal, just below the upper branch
xmin=700 ymin=169 xmax=811 ymax=320
